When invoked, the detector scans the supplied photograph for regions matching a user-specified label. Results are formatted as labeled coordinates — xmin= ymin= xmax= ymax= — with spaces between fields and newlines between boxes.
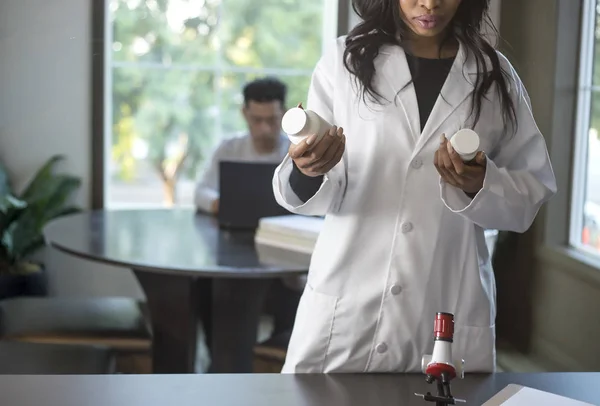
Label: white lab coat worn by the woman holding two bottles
xmin=273 ymin=37 xmax=556 ymax=373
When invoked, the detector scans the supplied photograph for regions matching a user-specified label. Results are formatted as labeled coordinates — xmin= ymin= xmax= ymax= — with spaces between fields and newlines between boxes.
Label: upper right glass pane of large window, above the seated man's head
xmin=219 ymin=0 xmax=330 ymax=70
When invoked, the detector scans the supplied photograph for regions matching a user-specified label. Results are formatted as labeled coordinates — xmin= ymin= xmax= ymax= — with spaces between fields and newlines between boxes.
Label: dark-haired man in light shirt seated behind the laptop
xmin=194 ymin=78 xmax=290 ymax=214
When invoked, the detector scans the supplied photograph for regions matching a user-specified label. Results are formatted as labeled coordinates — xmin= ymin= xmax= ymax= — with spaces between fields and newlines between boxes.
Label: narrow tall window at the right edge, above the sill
xmin=570 ymin=0 xmax=600 ymax=256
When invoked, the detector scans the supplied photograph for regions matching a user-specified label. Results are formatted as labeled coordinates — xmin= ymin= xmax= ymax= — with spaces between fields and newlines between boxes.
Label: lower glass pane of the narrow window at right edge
xmin=581 ymin=92 xmax=600 ymax=254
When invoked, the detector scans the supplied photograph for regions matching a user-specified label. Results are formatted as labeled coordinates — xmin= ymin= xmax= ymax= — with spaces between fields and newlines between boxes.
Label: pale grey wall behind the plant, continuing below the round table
xmin=0 ymin=0 xmax=142 ymax=297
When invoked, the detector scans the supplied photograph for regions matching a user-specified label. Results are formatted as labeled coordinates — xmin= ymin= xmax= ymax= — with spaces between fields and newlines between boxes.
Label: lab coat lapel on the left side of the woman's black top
xmin=379 ymin=45 xmax=421 ymax=145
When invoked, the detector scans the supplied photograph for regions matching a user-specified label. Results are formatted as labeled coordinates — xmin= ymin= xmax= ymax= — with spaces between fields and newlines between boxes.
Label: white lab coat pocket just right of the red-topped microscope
xmin=452 ymin=324 xmax=496 ymax=373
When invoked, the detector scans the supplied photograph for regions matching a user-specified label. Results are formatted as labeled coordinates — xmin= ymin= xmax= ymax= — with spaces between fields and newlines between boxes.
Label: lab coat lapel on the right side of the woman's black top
xmin=415 ymin=44 xmax=477 ymax=153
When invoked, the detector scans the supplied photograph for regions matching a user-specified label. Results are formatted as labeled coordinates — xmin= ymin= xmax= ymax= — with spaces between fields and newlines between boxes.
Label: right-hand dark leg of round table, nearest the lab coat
xmin=210 ymin=278 xmax=272 ymax=373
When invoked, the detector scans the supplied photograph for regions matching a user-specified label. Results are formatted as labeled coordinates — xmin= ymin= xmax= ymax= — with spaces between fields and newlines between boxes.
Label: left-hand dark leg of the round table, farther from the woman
xmin=134 ymin=270 xmax=197 ymax=374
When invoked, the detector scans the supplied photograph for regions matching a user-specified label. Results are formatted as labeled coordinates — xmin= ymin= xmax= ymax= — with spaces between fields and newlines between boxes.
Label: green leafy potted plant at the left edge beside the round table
xmin=0 ymin=155 xmax=81 ymax=299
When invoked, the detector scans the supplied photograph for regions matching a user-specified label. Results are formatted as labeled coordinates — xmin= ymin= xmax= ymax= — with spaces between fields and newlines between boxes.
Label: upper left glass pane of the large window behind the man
xmin=110 ymin=0 xmax=220 ymax=65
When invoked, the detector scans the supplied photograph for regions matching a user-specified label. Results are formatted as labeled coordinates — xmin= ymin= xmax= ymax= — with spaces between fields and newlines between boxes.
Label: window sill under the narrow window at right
xmin=536 ymin=246 xmax=600 ymax=286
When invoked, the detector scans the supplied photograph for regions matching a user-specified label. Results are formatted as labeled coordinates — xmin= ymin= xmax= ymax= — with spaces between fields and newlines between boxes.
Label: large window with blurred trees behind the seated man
xmin=103 ymin=0 xmax=338 ymax=208
